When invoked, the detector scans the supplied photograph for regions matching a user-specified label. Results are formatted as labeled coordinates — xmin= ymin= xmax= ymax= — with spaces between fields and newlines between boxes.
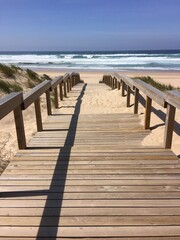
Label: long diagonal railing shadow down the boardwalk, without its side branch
xmin=37 ymin=84 xmax=86 ymax=239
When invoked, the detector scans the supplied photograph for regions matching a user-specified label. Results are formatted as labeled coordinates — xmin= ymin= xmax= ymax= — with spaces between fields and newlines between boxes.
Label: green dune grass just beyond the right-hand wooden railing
xmin=133 ymin=76 xmax=175 ymax=91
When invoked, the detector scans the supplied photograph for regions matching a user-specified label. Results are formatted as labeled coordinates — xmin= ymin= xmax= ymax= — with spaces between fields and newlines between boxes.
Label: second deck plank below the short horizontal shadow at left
xmin=0 ymin=206 xmax=180 ymax=218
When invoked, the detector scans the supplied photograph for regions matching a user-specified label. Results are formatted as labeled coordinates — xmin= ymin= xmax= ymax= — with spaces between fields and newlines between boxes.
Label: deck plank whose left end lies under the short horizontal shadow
xmin=1 ymin=190 xmax=179 ymax=200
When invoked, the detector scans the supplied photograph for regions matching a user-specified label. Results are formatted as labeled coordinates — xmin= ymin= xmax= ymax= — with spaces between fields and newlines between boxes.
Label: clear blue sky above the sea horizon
xmin=0 ymin=0 xmax=180 ymax=51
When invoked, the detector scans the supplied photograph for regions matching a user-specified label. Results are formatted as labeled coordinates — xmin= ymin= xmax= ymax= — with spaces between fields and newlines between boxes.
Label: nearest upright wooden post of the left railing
xmin=14 ymin=106 xmax=26 ymax=149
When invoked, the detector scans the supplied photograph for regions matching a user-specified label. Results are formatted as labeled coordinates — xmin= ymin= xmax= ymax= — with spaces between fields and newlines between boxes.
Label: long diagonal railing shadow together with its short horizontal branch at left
xmin=0 ymin=84 xmax=86 ymax=240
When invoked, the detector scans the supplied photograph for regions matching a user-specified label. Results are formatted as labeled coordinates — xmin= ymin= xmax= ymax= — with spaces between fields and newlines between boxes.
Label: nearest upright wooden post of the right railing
xmin=164 ymin=104 xmax=176 ymax=148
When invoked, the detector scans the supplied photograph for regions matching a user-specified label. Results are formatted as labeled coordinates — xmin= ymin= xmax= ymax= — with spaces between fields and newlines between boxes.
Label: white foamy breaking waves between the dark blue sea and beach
xmin=0 ymin=53 xmax=180 ymax=70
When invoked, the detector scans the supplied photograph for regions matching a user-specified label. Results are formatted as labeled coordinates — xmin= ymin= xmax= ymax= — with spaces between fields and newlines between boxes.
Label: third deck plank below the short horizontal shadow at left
xmin=0 ymin=215 xmax=180 ymax=227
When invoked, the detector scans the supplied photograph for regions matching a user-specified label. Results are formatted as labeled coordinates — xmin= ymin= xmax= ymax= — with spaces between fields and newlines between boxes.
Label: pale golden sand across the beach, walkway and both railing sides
xmin=0 ymin=71 xmax=180 ymax=171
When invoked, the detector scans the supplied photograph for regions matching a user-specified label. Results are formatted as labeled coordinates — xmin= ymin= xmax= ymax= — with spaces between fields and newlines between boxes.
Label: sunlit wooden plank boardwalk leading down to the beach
xmin=0 ymin=84 xmax=180 ymax=240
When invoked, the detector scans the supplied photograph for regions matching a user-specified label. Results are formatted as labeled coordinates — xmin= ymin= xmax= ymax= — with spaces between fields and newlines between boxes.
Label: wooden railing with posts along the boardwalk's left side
xmin=0 ymin=73 xmax=80 ymax=149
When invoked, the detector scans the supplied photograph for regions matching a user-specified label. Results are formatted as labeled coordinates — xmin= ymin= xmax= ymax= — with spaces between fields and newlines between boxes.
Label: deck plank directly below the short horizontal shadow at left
xmin=0 ymin=199 xmax=180 ymax=208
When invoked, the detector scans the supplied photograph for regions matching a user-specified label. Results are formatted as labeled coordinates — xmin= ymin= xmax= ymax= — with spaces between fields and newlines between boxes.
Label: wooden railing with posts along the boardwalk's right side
xmin=102 ymin=73 xmax=180 ymax=148
